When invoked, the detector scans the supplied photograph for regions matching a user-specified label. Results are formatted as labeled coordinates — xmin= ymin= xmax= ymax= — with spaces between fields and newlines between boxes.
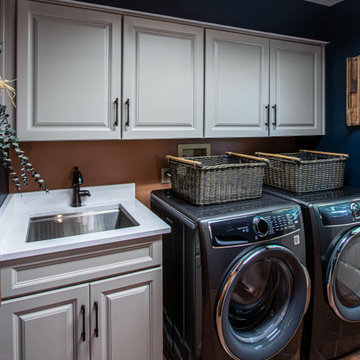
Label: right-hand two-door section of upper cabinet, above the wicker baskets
xmin=205 ymin=30 xmax=324 ymax=137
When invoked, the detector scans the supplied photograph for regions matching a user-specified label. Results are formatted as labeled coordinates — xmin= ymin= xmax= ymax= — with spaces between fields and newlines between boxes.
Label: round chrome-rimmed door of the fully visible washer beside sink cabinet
xmin=216 ymin=245 xmax=310 ymax=360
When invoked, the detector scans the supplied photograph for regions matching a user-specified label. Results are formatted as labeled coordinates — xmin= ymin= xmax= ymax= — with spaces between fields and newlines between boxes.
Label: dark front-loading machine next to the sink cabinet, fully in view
xmin=151 ymin=190 xmax=310 ymax=360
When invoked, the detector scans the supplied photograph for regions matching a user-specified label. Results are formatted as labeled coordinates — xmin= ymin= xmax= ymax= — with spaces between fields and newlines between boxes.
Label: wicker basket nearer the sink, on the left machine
xmin=167 ymin=152 xmax=268 ymax=205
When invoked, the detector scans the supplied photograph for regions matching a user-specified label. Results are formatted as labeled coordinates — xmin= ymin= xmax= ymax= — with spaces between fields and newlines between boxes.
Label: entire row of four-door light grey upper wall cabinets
xmin=13 ymin=0 xmax=325 ymax=141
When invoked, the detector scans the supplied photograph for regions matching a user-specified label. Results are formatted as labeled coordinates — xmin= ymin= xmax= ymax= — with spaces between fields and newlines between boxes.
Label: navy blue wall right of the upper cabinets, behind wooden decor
xmin=298 ymin=0 xmax=360 ymax=187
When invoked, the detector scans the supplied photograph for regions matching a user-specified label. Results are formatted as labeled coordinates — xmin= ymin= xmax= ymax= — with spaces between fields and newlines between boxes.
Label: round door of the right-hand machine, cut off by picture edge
xmin=326 ymin=227 xmax=360 ymax=322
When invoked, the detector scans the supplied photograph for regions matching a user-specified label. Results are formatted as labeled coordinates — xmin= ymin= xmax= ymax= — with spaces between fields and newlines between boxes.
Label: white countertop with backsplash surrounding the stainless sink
xmin=0 ymin=184 xmax=170 ymax=261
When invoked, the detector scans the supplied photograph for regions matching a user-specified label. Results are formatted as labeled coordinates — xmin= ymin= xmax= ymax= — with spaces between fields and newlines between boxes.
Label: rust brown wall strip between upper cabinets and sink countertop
xmin=10 ymin=138 xmax=295 ymax=206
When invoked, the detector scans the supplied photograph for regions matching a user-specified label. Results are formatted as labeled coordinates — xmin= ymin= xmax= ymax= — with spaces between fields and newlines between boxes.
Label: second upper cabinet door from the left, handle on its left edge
xmin=123 ymin=16 xmax=203 ymax=139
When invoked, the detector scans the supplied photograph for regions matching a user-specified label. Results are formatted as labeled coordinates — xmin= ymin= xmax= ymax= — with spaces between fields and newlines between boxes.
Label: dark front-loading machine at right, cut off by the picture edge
xmin=264 ymin=187 xmax=360 ymax=360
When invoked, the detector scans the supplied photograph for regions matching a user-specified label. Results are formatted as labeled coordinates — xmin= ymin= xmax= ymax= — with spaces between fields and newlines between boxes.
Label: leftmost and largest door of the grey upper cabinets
xmin=17 ymin=0 xmax=121 ymax=140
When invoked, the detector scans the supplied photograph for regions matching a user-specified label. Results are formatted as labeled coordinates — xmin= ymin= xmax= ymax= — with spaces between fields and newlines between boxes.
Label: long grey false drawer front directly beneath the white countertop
xmin=1 ymin=240 xmax=162 ymax=300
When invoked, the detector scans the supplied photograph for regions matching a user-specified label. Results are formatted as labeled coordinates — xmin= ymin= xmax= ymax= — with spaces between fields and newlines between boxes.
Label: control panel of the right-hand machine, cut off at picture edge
xmin=318 ymin=200 xmax=360 ymax=226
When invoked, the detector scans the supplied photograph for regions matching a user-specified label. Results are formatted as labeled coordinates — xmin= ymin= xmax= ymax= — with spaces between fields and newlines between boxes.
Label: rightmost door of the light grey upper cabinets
xmin=270 ymin=40 xmax=324 ymax=136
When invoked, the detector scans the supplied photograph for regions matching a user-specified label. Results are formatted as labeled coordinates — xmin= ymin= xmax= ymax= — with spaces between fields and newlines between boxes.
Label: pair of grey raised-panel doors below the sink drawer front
xmin=0 ymin=268 xmax=162 ymax=360
